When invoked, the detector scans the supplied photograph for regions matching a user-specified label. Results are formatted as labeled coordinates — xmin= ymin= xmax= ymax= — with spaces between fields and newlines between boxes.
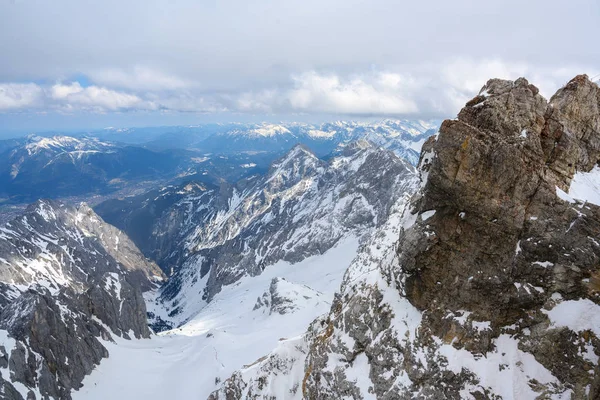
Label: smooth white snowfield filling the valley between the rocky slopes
xmin=73 ymin=238 xmax=359 ymax=400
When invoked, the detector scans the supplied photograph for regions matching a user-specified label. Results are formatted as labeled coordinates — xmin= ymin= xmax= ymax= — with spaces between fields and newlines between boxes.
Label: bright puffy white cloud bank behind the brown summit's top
xmin=234 ymin=58 xmax=586 ymax=117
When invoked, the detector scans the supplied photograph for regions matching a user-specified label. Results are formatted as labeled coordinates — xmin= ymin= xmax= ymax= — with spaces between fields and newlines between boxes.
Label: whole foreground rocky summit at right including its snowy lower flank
xmin=210 ymin=75 xmax=600 ymax=400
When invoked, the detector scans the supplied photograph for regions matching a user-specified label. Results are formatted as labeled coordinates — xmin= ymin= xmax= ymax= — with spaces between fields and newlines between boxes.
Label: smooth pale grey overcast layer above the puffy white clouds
xmin=0 ymin=0 xmax=600 ymax=90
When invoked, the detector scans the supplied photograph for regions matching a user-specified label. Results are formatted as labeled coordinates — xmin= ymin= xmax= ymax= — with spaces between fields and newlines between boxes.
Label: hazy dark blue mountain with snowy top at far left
xmin=0 ymin=136 xmax=191 ymax=203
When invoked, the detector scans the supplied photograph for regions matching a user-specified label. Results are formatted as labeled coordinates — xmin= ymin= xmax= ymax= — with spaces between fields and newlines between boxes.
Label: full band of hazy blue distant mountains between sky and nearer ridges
xmin=0 ymin=120 xmax=437 ymax=204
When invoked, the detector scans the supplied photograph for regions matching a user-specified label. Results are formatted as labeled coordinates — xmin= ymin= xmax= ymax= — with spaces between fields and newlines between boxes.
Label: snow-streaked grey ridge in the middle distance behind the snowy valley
xmin=97 ymin=141 xmax=416 ymax=325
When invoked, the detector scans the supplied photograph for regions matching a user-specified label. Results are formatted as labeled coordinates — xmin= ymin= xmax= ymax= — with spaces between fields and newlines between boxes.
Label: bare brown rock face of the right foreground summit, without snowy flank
xmin=400 ymin=77 xmax=600 ymax=325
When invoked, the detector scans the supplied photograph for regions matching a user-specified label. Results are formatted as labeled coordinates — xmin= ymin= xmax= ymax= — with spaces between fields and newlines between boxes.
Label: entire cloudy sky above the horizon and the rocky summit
xmin=0 ymin=0 xmax=600 ymax=130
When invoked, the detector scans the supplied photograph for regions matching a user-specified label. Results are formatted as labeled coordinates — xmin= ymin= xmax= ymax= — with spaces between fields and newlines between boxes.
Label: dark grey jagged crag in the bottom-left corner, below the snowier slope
xmin=0 ymin=287 xmax=111 ymax=399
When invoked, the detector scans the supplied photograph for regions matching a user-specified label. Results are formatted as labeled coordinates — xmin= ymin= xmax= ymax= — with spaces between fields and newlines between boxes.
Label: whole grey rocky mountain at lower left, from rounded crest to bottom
xmin=0 ymin=200 xmax=162 ymax=399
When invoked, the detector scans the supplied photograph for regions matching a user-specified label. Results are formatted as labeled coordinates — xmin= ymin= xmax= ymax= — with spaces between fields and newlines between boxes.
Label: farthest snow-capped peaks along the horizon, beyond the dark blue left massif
xmin=96 ymin=119 xmax=439 ymax=164
